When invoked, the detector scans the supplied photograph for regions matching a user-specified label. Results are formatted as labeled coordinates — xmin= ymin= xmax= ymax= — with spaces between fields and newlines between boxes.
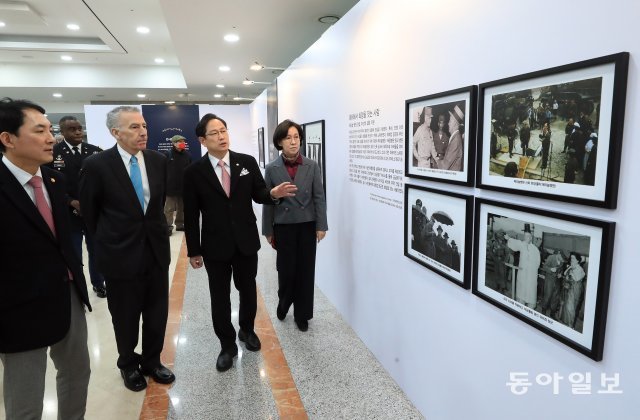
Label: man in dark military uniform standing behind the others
xmin=49 ymin=116 xmax=107 ymax=298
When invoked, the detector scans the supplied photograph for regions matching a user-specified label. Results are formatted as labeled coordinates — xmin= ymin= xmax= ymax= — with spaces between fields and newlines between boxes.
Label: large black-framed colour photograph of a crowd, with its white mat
xmin=476 ymin=53 xmax=629 ymax=208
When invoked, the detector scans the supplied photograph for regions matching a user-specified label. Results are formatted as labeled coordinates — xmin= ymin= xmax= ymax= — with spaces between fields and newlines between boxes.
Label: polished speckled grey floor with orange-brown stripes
xmin=0 ymin=217 xmax=423 ymax=420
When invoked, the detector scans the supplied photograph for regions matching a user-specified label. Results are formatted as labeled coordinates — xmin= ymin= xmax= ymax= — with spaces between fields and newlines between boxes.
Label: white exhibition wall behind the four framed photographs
xmin=272 ymin=0 xmax=640 ymax=419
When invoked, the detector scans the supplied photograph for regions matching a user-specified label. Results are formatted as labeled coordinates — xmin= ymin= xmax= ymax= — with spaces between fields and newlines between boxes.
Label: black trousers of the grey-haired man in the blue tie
xmin=105 ymin=245 xmax=169 ymax=369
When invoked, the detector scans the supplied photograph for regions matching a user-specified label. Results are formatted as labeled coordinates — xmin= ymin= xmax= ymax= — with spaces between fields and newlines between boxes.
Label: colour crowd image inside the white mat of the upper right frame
xmin=488 ymin=77 xmax=603 ymax=185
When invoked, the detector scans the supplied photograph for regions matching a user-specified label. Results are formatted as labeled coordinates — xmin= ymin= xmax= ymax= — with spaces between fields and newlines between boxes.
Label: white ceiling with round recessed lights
xmin=0 ymin=0 xmax=357 ymax=103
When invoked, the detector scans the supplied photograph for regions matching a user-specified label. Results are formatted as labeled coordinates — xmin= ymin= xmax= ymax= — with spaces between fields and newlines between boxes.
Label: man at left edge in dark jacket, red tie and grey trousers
xmin=0 ymin=98 xmax=91 ymax=419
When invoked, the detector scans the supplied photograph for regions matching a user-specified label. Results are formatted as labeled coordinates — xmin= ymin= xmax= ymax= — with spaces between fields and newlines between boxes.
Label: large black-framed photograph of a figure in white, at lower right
xmin=473 ymin=198 xmax=615 ymax=361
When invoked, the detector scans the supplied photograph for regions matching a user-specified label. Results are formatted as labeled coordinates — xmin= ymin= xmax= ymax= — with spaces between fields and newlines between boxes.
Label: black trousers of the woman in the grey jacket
xmin=273 ymin=222 xmax=317 ymax=321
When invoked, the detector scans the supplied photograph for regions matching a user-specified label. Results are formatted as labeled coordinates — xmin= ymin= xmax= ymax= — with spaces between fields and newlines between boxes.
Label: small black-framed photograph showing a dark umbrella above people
xmin=404 ymin=184 xmax=473 ymax=289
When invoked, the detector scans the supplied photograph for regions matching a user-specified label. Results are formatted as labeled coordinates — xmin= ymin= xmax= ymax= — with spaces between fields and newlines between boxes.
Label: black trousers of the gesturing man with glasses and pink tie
xmin=204 ymin=249 xmax=258 ymax=350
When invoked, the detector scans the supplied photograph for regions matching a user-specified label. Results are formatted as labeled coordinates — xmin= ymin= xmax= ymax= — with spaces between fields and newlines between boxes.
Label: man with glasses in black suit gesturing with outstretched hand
xmin=183 ymin=114 xmax=297 ymax=372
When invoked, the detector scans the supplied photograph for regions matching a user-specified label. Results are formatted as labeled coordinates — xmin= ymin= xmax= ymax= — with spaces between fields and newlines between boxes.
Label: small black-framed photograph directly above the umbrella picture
xmin=404 ymin=86 xmax=477 ymax=185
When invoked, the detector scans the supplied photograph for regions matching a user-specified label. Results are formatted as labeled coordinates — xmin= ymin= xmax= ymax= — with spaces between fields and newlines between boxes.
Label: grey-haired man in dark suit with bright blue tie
xmin=80 ymin=106 xmax=175 ymax=391
